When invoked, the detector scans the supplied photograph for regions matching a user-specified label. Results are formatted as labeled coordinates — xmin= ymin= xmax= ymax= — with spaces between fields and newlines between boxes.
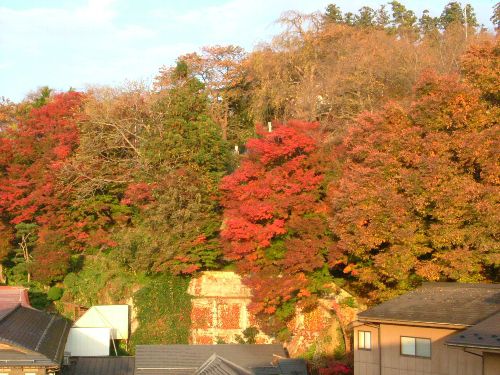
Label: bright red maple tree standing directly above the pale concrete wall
xmin=220 ymin=121 xmax=332 ymax=328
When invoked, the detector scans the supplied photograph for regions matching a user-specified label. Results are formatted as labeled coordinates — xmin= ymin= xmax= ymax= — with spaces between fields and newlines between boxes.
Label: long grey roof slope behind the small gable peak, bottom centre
xmin=135 ymin=344 xmax=287 ymax=375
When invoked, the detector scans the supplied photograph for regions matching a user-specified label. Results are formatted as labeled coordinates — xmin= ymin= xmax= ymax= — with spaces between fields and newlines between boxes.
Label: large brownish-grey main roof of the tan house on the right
xmin=358 ymin=283 xmax=500 ymax=326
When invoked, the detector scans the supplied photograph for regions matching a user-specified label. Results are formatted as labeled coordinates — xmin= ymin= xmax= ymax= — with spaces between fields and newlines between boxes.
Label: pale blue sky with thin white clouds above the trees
xmin=0 ymin=0 xmax=496 ymax=101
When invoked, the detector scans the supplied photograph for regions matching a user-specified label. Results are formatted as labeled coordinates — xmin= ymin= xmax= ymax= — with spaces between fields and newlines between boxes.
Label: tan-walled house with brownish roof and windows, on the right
xmin=354 ymin=283 xmax=500 ymax=375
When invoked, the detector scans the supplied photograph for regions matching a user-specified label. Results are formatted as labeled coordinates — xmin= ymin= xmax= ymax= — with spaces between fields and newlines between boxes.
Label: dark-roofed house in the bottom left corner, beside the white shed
xmin=0 ymin=304 xmax=70 ymax=375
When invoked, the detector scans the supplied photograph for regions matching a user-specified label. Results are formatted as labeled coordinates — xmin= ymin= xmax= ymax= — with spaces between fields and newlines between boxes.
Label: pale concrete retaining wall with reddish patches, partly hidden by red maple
xmin=188 ymin=271 xmax=356 ymax=356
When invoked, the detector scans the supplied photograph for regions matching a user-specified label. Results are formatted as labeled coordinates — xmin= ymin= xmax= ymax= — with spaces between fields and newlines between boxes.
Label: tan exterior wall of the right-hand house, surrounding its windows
xmin=354 ymin=324 xmax=483 ymax=375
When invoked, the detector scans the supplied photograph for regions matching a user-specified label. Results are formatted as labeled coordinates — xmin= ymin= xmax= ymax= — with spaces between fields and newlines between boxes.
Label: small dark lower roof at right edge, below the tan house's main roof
xmin=446 ymin=312 xmax=500 ymax=349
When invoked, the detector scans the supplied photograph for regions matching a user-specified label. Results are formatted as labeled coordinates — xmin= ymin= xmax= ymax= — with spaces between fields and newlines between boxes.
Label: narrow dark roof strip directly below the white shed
xmin=63 ymin=357 xmax=135 ymax=375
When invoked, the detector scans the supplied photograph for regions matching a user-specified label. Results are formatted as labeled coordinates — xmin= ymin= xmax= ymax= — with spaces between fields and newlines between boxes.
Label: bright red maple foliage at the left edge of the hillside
xmin=0 ymin=92 xmax=82 ymax=224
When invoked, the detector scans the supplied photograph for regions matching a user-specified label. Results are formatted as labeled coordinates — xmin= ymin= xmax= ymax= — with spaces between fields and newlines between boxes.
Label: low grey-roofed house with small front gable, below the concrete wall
xmin=134 ymin=344 xmax=307 ymax=375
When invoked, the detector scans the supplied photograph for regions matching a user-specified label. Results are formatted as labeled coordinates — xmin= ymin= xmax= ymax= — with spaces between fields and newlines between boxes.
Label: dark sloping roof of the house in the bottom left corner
xmin=0 ymin=306 xmax=70 ymax=365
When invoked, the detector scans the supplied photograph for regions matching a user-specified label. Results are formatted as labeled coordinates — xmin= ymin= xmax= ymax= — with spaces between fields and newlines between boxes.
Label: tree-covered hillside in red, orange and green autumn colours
xmin=0 ymin=1 xmax=500 ymax=343
